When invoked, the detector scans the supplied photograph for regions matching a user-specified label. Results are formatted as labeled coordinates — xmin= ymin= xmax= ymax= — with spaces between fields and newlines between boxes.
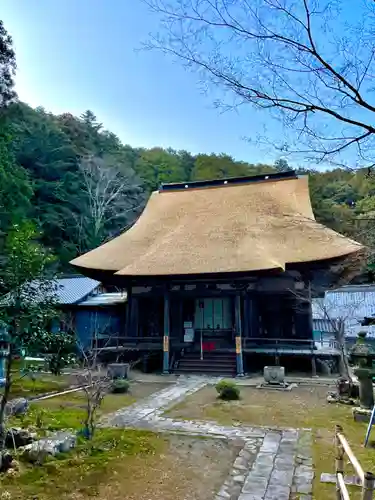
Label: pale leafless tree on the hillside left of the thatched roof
xmin=76 ymin=156 xmax=145 ymax=251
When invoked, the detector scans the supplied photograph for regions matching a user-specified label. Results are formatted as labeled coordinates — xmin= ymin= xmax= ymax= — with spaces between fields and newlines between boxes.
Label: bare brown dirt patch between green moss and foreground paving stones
xmin=93 ymin=435 xmax=241 ymax=500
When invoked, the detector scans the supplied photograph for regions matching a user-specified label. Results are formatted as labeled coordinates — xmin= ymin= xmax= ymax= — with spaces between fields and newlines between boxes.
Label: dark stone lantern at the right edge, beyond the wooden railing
xmin=349 ymin=332 xmax=375 ymax=410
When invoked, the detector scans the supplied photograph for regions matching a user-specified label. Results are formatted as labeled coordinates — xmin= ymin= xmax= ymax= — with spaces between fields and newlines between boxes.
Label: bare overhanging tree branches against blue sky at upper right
xmin=144 ymin=0 xmax=375 ymax=168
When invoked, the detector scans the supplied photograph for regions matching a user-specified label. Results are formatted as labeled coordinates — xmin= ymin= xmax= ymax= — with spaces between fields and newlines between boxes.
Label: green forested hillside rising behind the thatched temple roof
xmin=0 ymin=20 xmax=375 ymax=278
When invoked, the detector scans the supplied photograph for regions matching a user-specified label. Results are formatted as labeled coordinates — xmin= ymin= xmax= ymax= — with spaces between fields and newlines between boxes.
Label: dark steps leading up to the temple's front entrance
xmin=174 ymin=351 xmax=236 ymax=377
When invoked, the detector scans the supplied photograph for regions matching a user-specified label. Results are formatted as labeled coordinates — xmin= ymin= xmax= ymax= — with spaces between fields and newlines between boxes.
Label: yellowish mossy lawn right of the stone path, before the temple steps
xmin=168 ymin=386 xmax=375 ymax=500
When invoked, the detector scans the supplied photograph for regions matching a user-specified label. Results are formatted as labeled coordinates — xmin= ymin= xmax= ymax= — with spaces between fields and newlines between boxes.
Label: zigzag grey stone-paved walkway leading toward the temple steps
xmin=101 ymin=377 xmax=314 ymax=500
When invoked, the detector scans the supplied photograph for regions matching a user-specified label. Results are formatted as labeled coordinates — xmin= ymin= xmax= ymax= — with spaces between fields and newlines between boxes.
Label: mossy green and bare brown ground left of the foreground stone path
xmin=0 ymin=429 xmax=239 ymax=500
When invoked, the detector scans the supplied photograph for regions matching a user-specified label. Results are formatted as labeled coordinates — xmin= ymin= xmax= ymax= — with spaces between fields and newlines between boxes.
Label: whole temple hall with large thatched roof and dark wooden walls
xmin=71 ymin=172 xmax=363 ymax=375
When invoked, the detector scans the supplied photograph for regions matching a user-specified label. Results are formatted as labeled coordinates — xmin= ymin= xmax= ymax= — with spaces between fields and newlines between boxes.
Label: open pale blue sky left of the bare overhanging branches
xmin=0 ymin=0 xmax=276 ymax=162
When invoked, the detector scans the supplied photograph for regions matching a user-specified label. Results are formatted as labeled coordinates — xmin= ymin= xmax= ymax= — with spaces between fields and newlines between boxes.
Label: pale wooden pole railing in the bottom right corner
xmin=335 ymin=425 xmax=375 ymax=500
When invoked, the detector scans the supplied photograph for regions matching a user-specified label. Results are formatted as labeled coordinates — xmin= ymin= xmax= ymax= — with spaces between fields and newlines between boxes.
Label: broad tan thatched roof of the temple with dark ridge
xmin=71 ymin=175 xmax=362 ymax=276
